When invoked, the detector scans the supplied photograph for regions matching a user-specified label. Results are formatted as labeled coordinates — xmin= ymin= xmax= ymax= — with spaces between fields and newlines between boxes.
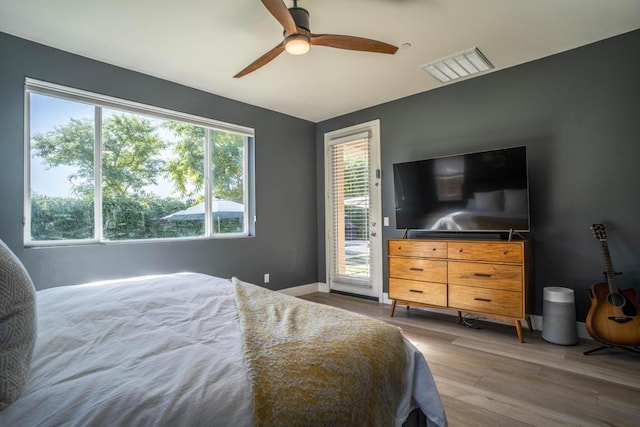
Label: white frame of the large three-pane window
xmin=23 ymin=77 xmax=255 ymax=247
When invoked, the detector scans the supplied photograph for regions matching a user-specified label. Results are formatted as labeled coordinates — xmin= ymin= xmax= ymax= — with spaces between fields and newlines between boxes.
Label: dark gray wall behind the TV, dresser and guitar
xmin=316 ymin=31 xmax=640 ymax=320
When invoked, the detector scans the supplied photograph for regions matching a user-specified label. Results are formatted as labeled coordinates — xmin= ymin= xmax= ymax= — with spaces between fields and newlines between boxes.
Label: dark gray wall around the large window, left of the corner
xmin=0 ymin=33 xmax=318 ymax=289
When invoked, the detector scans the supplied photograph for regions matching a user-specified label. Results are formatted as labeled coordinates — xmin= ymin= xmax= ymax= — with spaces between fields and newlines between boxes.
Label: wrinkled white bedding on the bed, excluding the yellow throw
xmin=0 ymin=273 xmax=446 ymax=427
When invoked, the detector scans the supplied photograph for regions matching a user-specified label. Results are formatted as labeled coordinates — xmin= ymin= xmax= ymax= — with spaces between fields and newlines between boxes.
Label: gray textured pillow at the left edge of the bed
xmin=0 ymin=240 xmax=36 ymax=410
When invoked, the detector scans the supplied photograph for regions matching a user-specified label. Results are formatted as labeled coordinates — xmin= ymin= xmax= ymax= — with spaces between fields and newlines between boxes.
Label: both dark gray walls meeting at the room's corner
xmin=0 ymin=31 xmax=640 ymax=320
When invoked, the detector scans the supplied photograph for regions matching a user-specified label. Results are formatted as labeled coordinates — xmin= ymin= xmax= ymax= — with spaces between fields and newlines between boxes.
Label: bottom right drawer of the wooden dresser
xmin=448 ymin=284 xmax=524 ymax=319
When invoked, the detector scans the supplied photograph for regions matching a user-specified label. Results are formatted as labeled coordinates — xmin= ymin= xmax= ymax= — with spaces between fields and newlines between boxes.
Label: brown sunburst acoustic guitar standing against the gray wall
xmin=586 ymin=224 xmax=640 ymax=347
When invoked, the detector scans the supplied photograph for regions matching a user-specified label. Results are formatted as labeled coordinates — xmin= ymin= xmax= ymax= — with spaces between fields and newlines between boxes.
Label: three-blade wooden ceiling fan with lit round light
xmin=233 ymin=0 xmax=398 ymax=78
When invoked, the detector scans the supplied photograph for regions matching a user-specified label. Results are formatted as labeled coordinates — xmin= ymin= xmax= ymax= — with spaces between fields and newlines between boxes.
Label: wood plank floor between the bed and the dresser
xmin=301 ymin=293 xmax=640 ymax=427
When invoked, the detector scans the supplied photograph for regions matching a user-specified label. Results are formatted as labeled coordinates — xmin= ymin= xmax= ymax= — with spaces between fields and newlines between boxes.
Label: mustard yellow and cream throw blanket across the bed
xmin=233 ymin=278 xmax=407 ymax=426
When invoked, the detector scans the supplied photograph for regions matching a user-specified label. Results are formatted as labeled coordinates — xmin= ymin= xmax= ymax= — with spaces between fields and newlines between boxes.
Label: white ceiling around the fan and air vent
xmin=0 ymin=0 xmax=640 ymax=122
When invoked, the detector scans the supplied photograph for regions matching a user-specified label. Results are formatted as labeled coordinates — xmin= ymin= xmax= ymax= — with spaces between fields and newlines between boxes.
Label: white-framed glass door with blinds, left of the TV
xmin=326 ymin=122 xmax=382 ymax=298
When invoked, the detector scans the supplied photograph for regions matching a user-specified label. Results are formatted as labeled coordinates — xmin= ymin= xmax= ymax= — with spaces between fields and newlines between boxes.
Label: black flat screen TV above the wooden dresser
xmin=393 ymin=147 xmax=529 ymax=232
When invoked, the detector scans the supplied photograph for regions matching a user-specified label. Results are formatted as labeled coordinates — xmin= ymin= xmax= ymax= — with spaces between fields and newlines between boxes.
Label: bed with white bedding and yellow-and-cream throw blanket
xmin=0 ymin=244 xmax=446 ymax=427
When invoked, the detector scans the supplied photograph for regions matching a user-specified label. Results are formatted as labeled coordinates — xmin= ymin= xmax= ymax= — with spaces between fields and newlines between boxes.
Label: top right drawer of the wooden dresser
xmin=448 ymin=242 xmax=524 ymax=263
